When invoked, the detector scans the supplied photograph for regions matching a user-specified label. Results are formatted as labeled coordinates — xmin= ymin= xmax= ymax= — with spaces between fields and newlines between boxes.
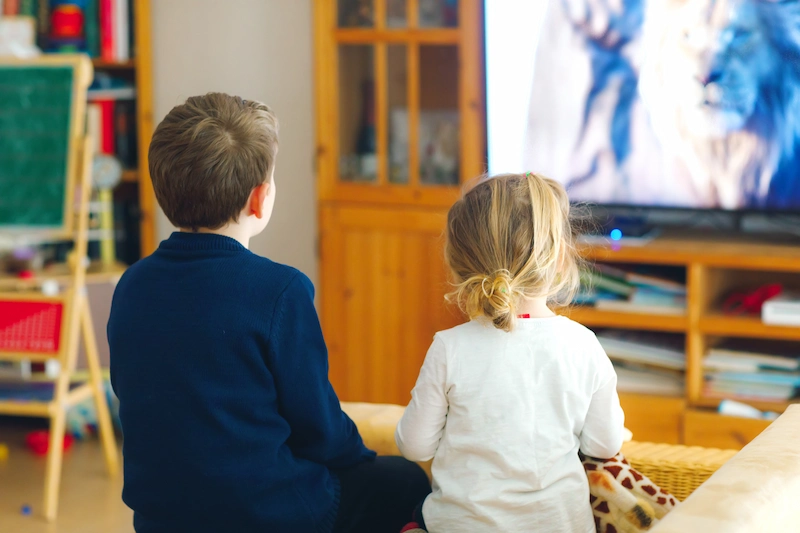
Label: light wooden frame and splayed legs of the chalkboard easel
xmin=0 ymin=56 xmax=119 ymax=520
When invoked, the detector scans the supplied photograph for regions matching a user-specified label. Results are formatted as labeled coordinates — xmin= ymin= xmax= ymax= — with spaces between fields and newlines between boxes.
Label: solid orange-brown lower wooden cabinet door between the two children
xmin=320 ymin=205 xmax=462 ymax=405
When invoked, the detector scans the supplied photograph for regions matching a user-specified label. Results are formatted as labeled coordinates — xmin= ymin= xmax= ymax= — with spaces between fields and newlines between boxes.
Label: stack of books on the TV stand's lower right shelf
xmin=703 ymin=339 xmax=800 ymax=401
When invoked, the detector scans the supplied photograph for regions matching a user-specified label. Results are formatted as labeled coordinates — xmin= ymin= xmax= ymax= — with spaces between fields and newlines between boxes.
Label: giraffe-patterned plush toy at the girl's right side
xmin=581 ymin=453 xmax=677 ymax=533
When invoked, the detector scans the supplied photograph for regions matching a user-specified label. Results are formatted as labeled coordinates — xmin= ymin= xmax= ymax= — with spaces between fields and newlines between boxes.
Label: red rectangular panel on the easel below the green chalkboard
xmin=0 ymin=300 xmax=64 ymax=353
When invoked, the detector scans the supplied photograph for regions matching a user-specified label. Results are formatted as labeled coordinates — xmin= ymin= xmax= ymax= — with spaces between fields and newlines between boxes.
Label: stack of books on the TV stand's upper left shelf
xmin=576 ymin=264 xmax=686 ymax=315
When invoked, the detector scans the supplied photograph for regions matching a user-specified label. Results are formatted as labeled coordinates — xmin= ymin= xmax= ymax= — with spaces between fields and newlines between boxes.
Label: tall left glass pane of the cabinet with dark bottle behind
xmin=338 ymin=44 xmax=378 ymax=182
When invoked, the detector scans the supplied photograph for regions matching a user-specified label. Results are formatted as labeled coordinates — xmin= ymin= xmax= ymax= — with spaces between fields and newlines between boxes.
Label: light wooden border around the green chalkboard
xmin=0 ymin=54 xmax=92 ymax=236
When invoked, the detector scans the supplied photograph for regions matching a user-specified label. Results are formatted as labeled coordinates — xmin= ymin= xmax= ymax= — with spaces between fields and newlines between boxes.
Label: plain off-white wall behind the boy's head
xmin=152 ymin=0 xmax=317 ymax=281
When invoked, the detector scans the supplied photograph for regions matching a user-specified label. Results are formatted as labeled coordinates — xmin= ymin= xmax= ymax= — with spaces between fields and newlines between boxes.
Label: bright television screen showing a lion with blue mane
xmin=485 ymin=0 xmax=800 ymax=211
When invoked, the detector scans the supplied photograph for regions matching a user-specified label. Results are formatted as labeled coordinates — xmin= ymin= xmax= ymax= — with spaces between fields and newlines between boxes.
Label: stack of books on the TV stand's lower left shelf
xmin=597 ymin=330 xmax=686 ymax=395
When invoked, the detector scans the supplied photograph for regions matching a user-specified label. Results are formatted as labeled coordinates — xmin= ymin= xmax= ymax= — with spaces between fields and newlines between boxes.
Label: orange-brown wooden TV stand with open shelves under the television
xmin=576 ymin=236 xmax=800 ymax=448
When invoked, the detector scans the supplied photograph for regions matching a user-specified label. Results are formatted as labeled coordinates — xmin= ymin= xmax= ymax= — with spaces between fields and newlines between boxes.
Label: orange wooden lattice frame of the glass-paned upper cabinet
xmin=314 ymin=0 xmax=485 ymax=207
